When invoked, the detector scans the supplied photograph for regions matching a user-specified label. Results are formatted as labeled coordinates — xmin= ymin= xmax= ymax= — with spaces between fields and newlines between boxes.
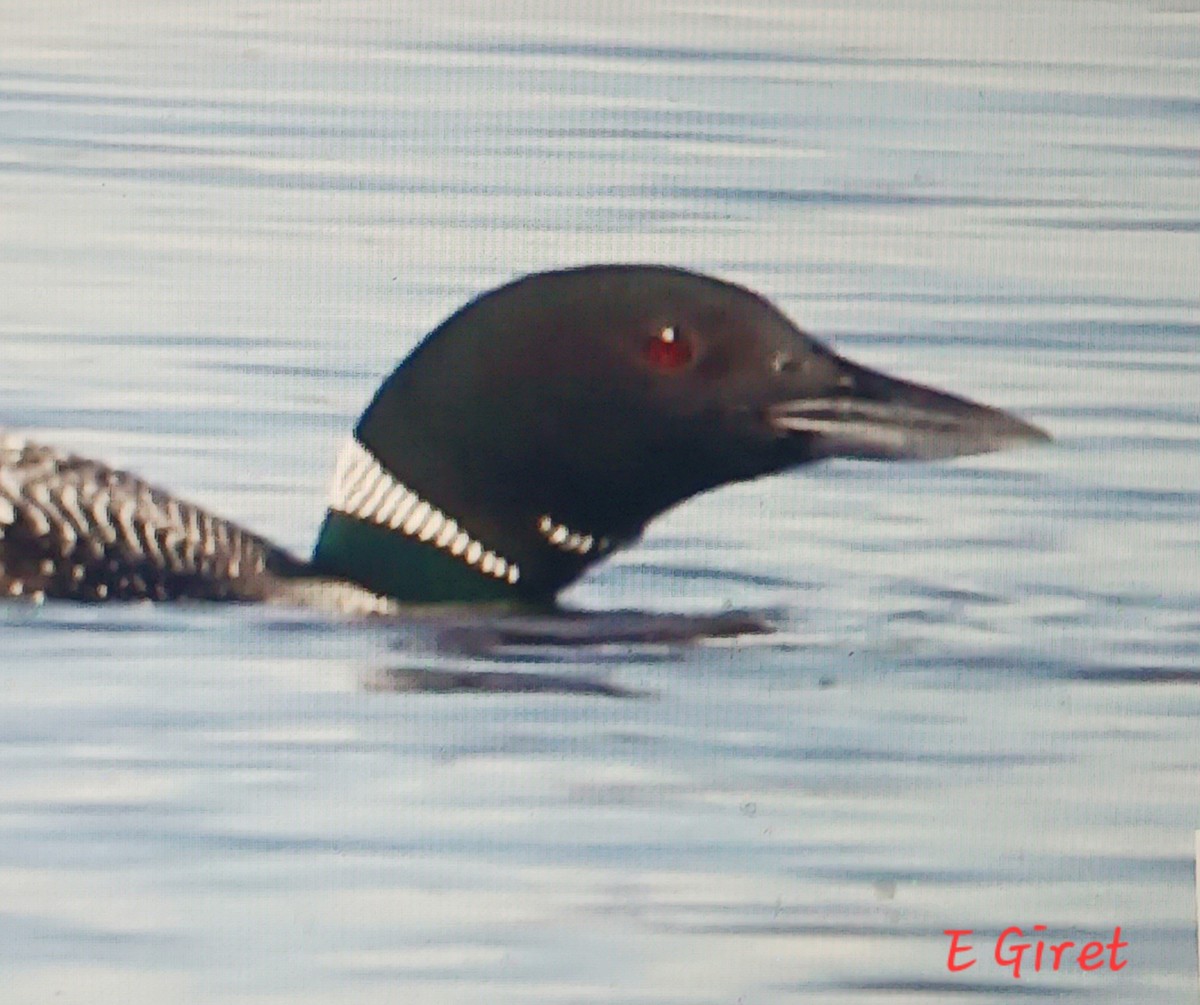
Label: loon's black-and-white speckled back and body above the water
xmin=0 ymin=434 xmax=385 ymax=610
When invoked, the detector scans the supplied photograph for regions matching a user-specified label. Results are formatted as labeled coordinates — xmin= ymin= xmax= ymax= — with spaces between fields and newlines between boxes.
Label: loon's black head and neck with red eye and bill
xmin=314 ymin=265 xmax=1048 ymax=602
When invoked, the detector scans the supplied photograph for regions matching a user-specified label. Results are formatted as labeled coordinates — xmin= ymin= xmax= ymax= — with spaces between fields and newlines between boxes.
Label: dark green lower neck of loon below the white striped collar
xmin=312 ymin=510 xmax=520 ymax=603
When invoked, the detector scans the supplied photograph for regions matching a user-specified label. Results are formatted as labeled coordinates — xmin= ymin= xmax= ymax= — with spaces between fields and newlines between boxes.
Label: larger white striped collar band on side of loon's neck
xmin=329 ymin=438 xmax=521 ymax=584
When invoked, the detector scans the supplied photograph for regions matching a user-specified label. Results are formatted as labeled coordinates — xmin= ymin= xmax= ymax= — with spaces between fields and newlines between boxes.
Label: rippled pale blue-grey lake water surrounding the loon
xmin=0 ymin=0 xmax=1200 ymax=1005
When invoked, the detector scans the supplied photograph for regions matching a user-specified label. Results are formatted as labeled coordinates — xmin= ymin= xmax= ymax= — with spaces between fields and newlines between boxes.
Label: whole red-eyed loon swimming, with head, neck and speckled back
xmin=0 ymin=265 xmax=1049 ymax=612
